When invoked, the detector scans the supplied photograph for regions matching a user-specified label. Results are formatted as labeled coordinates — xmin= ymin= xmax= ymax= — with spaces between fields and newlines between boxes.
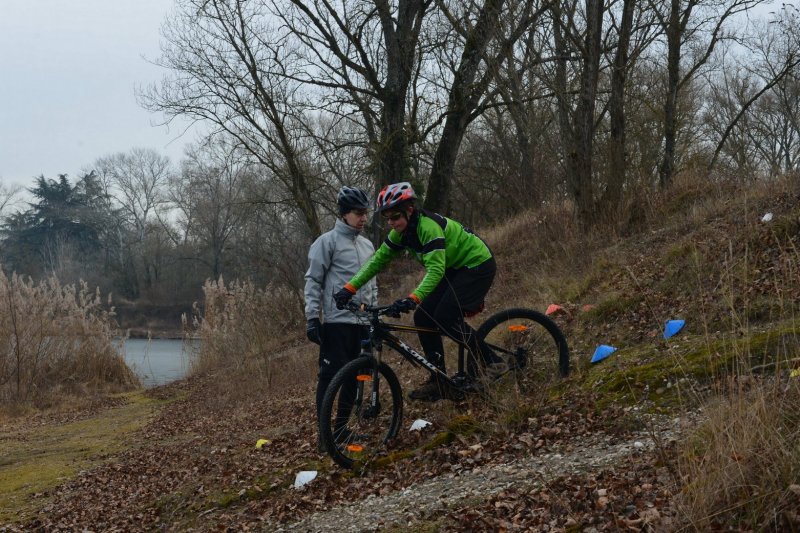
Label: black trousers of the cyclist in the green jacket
xmin=414 ymin=258 xmax=497 ymax=370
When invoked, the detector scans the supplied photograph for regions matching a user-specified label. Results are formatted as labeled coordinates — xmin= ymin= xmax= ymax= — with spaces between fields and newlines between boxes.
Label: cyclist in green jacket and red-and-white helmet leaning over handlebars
xmin=334 ymin=182 xmax=505 ymax=401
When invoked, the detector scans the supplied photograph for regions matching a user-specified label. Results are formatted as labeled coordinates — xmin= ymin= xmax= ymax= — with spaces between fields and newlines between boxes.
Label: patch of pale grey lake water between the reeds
xmin=117 ymin=339 xmax=195 ymax=387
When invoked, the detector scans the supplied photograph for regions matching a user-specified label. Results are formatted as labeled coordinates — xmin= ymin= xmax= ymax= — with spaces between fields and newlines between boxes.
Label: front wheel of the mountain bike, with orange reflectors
xmin=319 ymin=357 xmax=403 ymax=469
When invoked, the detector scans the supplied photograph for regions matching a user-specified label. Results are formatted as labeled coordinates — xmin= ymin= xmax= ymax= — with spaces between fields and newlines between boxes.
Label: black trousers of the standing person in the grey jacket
xmin=317 ymin=322 xmax=369 ymax=415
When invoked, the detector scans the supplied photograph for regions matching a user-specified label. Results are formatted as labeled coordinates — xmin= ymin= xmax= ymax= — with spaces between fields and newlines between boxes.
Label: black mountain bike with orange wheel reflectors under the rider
xmin=319 ymin=303 xmax=569 ymax=469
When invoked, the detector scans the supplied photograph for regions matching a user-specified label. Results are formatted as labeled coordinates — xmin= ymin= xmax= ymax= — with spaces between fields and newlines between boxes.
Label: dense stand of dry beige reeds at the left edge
xmin=0 ymin=271 xmax=140 ymax=409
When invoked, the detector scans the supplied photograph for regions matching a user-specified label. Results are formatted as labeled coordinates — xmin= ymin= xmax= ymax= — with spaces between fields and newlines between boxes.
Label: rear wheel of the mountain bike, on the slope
xmin=477 ymin=308 xmax=569 ymax=385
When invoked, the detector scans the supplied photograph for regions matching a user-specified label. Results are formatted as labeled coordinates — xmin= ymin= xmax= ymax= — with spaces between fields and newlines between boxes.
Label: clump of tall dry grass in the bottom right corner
xmin=679 ymin=379 xmax=800 ymax=531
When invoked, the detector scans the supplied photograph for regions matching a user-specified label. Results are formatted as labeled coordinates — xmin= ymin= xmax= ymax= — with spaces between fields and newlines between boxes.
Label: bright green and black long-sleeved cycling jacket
xmin=346 ymin=209 xmax=492 ymax=303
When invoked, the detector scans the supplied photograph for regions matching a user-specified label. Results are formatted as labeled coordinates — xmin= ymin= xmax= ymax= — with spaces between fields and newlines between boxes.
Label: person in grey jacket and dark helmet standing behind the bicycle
xmin=305 ymin=186 xmax=378 ymax=452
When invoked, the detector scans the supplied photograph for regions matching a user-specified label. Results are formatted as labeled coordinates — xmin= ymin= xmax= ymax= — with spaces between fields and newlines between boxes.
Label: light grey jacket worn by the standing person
xmin=305 ymin=219 xmax=378 ymax=324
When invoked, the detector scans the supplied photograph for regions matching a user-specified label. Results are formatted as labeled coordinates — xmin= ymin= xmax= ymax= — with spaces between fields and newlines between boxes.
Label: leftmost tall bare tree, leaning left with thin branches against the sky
xmin=140 ymin=0 xmax=321 ymax=236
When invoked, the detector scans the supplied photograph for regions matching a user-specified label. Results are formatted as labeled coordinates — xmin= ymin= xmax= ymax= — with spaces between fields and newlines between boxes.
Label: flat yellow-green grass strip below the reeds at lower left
xmin=0 ymin=392 xmax=164 ymax=522
